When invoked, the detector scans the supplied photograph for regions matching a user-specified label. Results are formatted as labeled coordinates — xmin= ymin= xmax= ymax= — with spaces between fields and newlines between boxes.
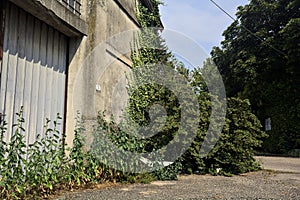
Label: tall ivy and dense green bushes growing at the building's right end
xmin=117 ymin=0 xmax=265 ymax=176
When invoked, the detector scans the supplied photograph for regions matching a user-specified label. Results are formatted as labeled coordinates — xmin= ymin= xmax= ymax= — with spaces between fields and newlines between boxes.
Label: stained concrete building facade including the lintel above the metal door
xmin=5 ymin=0 xmax=144 ymax=149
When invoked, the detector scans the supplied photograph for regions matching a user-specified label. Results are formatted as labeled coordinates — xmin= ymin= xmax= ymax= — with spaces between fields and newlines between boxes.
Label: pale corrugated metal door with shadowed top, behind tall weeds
xmin=0 ymin=3 xmax=68 ymax=143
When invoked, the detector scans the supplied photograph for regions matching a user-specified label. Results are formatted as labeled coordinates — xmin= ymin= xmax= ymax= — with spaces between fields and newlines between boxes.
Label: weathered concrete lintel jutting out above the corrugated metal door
xmin=10 ymin=0 xmax=88 ymax=37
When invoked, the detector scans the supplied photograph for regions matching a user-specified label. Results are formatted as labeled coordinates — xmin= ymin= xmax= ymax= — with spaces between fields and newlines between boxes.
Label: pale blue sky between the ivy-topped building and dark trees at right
xmin=160 ymin=0 xmax=249 ymax=65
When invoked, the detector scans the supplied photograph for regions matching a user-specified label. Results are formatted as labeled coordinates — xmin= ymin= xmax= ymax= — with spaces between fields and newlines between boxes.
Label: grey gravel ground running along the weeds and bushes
xmin=57 ymin=157 xmax=300 ymax=200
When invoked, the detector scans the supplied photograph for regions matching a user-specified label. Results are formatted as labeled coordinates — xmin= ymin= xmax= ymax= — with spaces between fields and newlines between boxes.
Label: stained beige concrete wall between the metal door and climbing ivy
xmin=66 ymin=0 xmax=138 ymax=146
